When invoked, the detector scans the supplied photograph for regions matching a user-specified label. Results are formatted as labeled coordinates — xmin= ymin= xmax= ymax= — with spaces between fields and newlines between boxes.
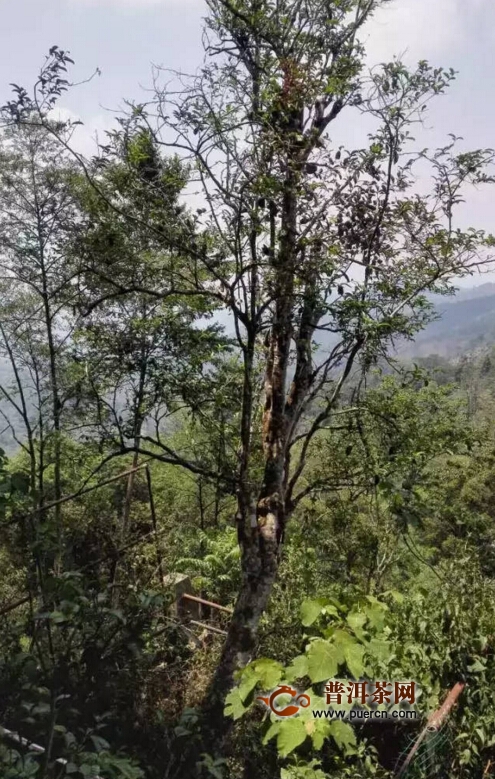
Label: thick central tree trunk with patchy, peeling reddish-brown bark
xmin=202 ymin=174 xmax=297 ymax=742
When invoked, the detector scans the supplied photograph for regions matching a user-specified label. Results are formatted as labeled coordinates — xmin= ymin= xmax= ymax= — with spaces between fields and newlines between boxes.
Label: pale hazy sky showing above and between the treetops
xmin=0 ymin=0 xmax=495 ymax=283
